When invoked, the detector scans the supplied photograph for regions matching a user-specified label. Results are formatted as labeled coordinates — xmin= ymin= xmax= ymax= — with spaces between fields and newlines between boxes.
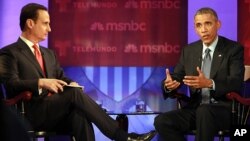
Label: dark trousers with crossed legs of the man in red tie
xmin=25 ymin=88 xmax=128 ymax=141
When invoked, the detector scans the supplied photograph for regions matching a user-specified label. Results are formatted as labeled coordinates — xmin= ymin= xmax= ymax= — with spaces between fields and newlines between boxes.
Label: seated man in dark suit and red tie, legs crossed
xmin=0 ymin=3 xmax=155 ymax=141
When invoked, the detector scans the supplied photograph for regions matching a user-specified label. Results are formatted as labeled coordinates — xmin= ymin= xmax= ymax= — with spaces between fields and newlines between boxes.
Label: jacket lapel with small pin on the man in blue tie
xmin=210 ymin=37 xmax=224 ymax=78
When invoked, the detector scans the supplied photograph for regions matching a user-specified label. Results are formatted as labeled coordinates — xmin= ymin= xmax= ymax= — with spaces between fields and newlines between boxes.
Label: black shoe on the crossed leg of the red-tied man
xmin=128 ymin=130 xmax=156 ymax=141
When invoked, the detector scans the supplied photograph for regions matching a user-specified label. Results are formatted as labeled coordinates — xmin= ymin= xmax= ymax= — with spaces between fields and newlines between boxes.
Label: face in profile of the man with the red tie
xmin=31 ymin=10 xmax=51 ymax=42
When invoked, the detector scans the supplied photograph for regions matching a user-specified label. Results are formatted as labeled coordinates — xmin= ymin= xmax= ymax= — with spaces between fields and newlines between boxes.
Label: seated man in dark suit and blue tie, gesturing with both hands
xmin=154 ymin=7 xmax=244 ymax=141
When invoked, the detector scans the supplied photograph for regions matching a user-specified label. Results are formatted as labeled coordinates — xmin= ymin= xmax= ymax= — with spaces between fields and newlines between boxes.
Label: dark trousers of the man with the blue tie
xmin=154 ymin=102 xmax=231 ymax=141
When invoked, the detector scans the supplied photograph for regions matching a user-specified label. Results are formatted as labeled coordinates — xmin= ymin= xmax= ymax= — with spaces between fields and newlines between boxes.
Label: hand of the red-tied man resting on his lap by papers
xmin=38 ymin=78 xmax=67 ymax=93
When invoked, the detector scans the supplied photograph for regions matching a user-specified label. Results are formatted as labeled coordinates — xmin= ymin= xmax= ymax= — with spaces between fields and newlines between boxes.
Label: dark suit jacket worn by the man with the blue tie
xmin=162 ymin=36 xmax=244 ymax=107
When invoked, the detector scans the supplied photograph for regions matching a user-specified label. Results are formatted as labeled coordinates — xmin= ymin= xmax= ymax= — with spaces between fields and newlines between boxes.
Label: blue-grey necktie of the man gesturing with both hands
xmin=201 ymin=48 xmax=212 ymax=104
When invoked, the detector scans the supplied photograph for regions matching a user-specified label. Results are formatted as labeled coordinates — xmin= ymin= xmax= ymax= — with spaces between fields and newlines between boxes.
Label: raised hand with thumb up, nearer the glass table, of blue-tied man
xmin=164 ymin=69 xmax=180 ymax=91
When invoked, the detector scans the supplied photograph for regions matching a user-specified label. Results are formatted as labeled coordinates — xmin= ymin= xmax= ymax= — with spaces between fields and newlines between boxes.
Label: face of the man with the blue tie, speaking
xmin=194 ymin=14 xmax=221 ymax=46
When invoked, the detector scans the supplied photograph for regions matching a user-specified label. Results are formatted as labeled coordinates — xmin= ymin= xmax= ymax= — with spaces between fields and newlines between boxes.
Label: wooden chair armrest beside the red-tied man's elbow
xmin=4 ymin=91 xmax=32 ymax=106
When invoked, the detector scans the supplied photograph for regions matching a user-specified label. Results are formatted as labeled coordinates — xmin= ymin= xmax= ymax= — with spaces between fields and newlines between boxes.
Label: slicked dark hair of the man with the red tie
xmin=19 ymin=3 xmax=47 ymax=31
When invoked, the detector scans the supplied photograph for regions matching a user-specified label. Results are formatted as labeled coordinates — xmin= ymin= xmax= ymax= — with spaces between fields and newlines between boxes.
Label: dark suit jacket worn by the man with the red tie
xmin=0 ymin=38 xmax=72 ymax=98
